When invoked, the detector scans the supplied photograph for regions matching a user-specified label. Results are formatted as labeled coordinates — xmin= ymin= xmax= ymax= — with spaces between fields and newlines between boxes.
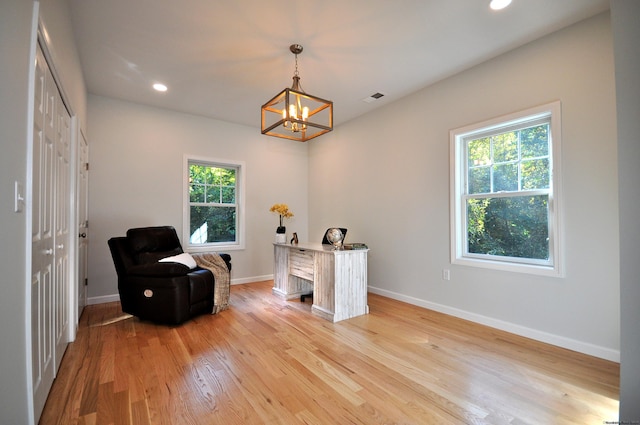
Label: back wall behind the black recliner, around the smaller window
xmin=88 ymin=96 xmax=308 ymax=303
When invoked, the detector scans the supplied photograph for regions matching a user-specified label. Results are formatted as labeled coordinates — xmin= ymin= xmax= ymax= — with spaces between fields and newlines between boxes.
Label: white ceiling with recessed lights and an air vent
xmin=69 ymin=0 xmax=609 ymax=127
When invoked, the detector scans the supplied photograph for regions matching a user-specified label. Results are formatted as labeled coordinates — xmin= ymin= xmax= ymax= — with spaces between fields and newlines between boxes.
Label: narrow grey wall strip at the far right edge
xmin=611 ymin=0 xmax=640 ymax=423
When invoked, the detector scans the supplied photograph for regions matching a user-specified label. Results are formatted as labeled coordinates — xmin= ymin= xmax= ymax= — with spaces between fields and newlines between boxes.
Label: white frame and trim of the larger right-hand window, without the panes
xmin=449 ymin=101 xmax=564 ymax=277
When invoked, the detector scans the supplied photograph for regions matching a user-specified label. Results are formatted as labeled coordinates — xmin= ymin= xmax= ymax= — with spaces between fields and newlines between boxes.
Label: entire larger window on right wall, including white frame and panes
xmin=450 ymin=102 xmax=561 ymax=275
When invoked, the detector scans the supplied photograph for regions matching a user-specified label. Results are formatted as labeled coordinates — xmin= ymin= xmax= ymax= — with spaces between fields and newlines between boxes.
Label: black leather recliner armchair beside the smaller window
xmin=108 ymin=226 xmax=231 ymax=324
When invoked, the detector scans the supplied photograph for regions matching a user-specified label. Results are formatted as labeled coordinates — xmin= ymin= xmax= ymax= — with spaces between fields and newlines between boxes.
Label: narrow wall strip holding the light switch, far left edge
xmin=0 ymin=4 xmax=33 ymax=424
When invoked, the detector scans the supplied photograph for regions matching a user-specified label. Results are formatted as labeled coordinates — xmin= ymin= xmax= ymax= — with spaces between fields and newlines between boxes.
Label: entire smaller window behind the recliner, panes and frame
xmin=183 ymin=157 xmax=244 ymax=251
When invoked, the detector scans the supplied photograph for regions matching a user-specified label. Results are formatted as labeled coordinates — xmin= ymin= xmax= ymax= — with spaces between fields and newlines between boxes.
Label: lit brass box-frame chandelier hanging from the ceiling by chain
xmin=261 ymin=44 xmax=333 ymax=142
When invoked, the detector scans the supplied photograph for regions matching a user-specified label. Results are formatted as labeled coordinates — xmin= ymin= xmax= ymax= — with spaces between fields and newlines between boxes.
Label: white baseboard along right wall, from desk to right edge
xmin=368 ymin=286 xmax=620 ymax=363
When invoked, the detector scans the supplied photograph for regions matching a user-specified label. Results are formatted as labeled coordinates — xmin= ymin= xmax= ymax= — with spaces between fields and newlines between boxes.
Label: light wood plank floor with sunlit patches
xmin=40 ymin=281 xmax=619 ymax=425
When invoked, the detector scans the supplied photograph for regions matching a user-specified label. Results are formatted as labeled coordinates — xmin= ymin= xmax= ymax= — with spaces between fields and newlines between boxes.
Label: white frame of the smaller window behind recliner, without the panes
xmin=182 ymin=155 xmax=246 ymax=252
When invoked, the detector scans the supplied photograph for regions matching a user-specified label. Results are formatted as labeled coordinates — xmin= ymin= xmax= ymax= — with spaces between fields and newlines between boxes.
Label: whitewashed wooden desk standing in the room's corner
xmin=272 ymin=243 xmax=369 ymax=322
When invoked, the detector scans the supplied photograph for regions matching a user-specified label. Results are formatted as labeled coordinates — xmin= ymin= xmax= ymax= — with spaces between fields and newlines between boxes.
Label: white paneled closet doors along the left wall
xmin=31 ymin=42 xmax=74 ymax=418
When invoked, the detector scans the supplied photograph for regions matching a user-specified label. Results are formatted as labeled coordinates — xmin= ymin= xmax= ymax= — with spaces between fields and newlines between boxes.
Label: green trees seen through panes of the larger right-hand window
xmin=464 ymin=123 xmax=551 ymax=260
